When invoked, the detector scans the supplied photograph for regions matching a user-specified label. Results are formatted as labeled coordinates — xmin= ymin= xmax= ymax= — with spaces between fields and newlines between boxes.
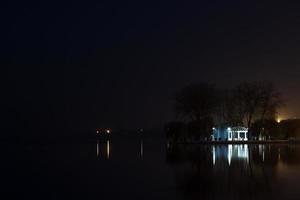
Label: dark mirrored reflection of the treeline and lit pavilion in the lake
xmin=167 ymin=145 xmax=300 ymax=199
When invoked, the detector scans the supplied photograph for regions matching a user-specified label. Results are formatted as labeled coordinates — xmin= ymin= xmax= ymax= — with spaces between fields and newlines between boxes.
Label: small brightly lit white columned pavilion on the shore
xmin=212 ymin=126 xmax=248 ymax=141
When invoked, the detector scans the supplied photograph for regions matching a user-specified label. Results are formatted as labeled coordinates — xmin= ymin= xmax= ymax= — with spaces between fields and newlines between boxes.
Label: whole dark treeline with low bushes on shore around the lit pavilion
xmin=165 ymin=82 xmax=300 ymax=140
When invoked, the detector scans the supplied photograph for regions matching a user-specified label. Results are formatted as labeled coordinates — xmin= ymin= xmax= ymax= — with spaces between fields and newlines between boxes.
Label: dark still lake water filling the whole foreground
xmin=0 ymin=140 xmax=300 ymax=200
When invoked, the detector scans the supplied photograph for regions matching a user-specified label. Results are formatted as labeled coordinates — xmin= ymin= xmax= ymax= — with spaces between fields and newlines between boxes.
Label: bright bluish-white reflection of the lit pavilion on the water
xmin=212 ymin=144 xmax=249 ymax=165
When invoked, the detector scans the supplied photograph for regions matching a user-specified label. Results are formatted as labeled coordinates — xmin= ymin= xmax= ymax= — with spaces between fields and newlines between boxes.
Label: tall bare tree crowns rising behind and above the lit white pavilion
xmin=169 ymin=82 xmax=283 ymax=138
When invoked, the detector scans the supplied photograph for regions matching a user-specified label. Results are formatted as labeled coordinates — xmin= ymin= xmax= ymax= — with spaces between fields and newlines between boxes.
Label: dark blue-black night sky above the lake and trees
xmin=0 ymin=0 xmax=300 ymax=134
